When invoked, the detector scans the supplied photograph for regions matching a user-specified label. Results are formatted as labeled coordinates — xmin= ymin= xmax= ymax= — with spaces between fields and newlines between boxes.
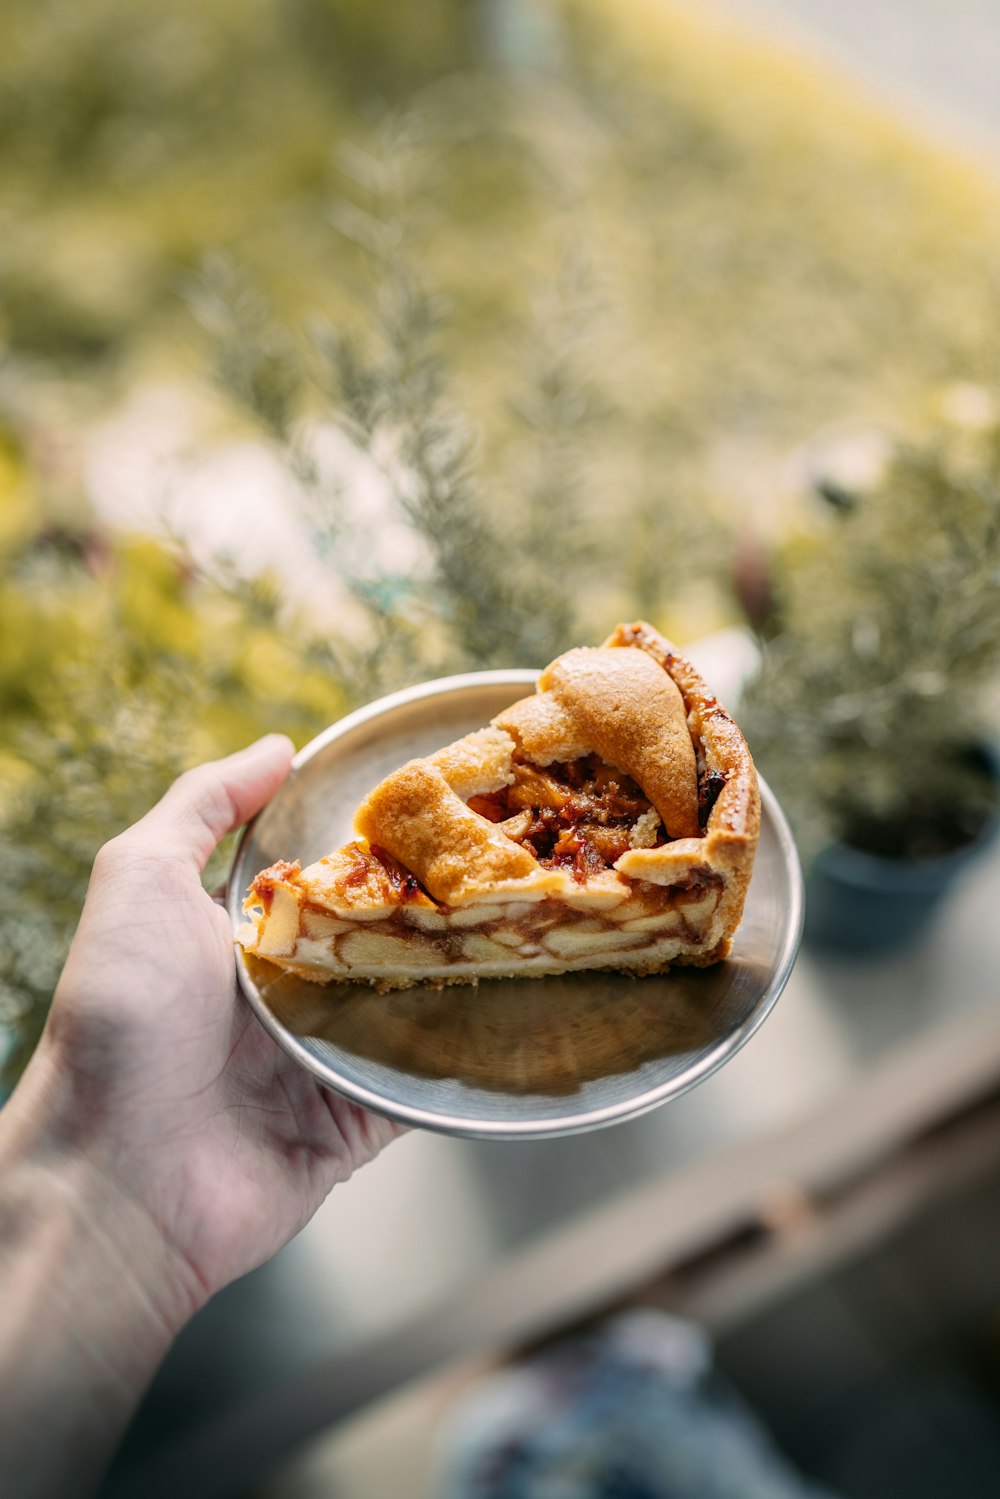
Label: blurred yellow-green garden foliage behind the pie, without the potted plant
xmin=0 ymin=0 xmax=1000 ymax=1070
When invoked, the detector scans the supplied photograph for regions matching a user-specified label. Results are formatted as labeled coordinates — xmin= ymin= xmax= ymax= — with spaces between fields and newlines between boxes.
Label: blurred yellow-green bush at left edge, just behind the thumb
xmin=0 ymin=531 xmax=346 ymax=1072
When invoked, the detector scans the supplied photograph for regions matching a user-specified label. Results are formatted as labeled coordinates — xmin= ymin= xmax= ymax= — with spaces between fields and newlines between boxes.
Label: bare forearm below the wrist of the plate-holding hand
xmin=0 ymin=1058 xmax=193 ymax=1499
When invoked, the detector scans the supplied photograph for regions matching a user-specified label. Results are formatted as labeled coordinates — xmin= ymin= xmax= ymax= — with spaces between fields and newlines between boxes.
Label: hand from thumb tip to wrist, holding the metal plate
xmin=9 ymin=735 xmax=397 ymax=1325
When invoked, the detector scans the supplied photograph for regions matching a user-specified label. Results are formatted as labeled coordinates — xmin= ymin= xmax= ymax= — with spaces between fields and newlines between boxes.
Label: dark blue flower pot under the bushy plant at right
xmin=805 ymin=820 xmax=997 ymax=953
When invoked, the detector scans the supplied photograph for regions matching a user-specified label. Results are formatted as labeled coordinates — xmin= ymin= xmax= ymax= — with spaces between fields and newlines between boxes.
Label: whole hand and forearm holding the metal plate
xmin=0 ymin=736 xmax=399 ymax=1499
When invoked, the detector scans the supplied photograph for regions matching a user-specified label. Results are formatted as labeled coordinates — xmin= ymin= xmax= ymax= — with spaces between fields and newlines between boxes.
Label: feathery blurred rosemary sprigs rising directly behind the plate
xmin=192 ymin=117 xmax=598 ymax=694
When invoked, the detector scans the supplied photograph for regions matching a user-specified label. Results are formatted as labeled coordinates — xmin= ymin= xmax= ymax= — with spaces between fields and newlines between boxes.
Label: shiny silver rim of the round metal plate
xmin=225 ymin=667 xmax=805 ymax=1139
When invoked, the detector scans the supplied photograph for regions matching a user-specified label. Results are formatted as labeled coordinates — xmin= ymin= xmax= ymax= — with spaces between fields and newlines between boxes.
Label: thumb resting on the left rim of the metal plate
xmin=121 ymin=735 xmax=295 ymax=869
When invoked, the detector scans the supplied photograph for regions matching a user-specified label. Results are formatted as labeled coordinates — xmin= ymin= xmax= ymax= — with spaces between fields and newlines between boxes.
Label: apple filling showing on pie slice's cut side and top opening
xmin=241 ymin=754 xmax=723 ymax=986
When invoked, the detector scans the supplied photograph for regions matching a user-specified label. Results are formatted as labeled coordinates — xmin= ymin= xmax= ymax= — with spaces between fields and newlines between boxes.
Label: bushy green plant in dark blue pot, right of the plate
xmin=744 ymin=387 xmax=1000 ymax=950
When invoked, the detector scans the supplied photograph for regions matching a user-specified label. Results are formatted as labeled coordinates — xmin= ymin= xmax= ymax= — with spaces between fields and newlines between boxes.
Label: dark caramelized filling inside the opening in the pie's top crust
xmin=469 ymin=754 xmax=666 ymax=881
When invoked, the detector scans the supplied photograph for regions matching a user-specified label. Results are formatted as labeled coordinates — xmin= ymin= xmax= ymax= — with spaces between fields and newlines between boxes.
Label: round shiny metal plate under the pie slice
xmin=226 ymin=672 xmax=804 ymax=1139
